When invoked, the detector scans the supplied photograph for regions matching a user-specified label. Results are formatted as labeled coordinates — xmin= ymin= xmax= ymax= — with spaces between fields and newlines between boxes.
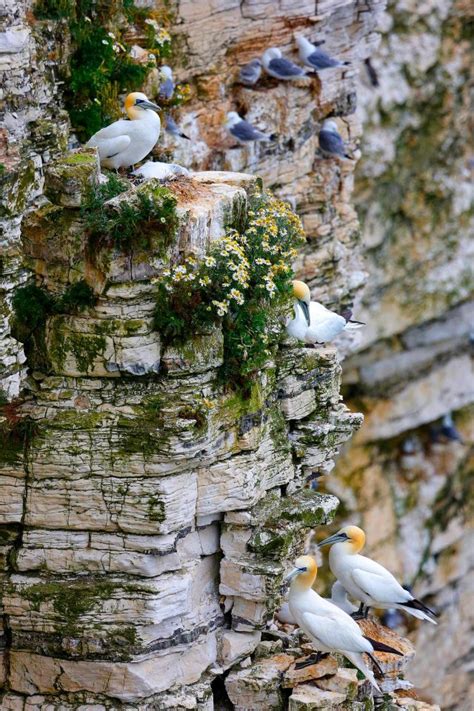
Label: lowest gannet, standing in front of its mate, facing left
xmin=286 ymin=555 xmax=400 ymax=691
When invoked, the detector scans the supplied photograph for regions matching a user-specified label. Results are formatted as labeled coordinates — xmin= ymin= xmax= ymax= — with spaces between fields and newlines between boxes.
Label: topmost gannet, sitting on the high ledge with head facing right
xmin=86 ymin=91 xmax=161 ymax=170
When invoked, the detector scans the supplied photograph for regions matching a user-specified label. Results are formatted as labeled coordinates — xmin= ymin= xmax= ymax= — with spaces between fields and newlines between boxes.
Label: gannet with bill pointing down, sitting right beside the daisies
xmin=286 ymin=279 xmax=365 ymax=344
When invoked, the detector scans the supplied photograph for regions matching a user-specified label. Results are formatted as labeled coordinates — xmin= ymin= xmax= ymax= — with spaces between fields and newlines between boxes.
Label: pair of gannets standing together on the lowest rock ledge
xmin=278 ymin=526 xmax=436 ymax=692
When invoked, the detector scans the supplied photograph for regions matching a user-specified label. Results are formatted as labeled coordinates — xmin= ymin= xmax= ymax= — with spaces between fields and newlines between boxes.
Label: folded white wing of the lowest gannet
xmin=301 ymin=607 xmax=372 ymax=652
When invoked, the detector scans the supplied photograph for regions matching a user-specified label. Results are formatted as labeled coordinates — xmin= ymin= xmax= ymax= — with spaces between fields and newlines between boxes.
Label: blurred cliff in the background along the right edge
xmin=327 ymin=1 xmax=474 ymax=711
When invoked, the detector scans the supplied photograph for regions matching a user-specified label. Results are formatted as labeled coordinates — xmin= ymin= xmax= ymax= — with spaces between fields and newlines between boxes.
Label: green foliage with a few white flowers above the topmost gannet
xmin=34 ymin=0 xmax=171 ymax=140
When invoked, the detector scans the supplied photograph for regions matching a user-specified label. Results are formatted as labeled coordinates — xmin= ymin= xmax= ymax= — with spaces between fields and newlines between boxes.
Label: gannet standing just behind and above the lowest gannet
xmin=318 ymin=526 xmax=436 ymax=624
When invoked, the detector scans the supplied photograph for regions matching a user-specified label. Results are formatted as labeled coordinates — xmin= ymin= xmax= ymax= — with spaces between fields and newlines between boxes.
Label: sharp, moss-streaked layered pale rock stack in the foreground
xmin=3 ymin=151 xmax=360 ymax=708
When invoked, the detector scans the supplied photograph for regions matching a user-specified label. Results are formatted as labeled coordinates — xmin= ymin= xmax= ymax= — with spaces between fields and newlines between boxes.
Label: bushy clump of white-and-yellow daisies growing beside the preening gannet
xmin=154 ymin=194 xmax=304 ymax=379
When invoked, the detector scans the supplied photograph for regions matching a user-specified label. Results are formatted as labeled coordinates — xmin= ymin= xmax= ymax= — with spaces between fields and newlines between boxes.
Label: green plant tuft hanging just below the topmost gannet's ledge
xmin=81 ymin=175 xmax=178 ymax=252
